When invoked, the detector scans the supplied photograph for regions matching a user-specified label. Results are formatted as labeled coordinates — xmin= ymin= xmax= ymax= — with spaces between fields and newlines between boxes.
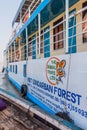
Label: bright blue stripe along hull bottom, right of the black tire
xmin=27 ymin=93 xmax=55 ymax=114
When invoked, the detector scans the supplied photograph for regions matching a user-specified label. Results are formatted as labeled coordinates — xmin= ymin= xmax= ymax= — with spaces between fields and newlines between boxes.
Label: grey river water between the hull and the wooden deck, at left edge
xmin=0 ymin=73 xmax=20 ymax=97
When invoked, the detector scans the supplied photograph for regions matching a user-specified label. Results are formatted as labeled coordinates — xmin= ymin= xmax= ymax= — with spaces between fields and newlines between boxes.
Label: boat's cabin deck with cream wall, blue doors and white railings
xmin=5 ymin=0 xmax=87 ymax=63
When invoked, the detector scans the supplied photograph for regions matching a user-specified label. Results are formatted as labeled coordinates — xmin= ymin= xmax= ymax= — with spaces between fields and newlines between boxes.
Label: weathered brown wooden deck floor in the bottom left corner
xmin=0 ymin=101 xmax=43 ymax=130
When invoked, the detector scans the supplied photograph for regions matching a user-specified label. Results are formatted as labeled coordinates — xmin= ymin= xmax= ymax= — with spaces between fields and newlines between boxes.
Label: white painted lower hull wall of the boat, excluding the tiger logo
xmin=9 ymin=52 xmax=87 ymax=130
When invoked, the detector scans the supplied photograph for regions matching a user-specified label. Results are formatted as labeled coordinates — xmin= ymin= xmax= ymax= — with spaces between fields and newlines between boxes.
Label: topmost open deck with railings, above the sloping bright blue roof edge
xmin=8 ymin=0 xmax=43 ymax=44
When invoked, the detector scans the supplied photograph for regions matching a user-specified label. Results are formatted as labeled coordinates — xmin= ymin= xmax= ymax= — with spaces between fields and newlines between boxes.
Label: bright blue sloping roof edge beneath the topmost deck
xmin=9 ymin=0 xmax=51 ymax=46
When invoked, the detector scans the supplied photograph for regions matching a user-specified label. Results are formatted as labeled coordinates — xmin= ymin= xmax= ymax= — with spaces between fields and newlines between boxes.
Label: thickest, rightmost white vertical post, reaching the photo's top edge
xmin=65 ymin=0 xmax=69 ymax=53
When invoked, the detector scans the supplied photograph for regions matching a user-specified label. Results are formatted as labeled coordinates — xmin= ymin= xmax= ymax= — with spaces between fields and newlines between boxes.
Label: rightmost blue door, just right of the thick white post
xmin=68 ymin=9 xmax=76 ymax=53
